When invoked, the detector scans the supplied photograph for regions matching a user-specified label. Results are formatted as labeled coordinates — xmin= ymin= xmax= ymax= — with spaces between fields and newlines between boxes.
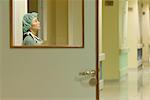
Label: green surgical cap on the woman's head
xmin=22 ymin=12 xmax=38 ymax=33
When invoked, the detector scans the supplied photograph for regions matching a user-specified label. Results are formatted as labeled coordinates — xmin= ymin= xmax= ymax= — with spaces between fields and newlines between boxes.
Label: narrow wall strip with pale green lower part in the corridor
xmin=119 ymin=0 xmax=129 ymax=79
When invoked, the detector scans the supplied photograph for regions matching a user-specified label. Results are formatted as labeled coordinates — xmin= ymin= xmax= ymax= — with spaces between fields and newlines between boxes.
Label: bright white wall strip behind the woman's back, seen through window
xmin=13 ymin=0 xmax=27 ymax=46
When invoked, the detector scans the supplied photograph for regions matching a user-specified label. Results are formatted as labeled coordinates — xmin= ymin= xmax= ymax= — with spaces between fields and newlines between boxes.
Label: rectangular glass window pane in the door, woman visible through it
xmin=10 ymin=0 xmax=84 ymax=47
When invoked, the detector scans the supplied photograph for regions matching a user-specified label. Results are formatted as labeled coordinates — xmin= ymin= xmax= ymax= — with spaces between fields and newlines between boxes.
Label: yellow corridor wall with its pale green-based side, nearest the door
xmin=102 ymin=0 xmax=128 ymax=80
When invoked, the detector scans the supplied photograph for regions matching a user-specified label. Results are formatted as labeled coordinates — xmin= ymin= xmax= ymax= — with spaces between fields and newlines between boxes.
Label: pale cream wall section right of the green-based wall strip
xmin=128 ymin=0 xmax=140 ymax=68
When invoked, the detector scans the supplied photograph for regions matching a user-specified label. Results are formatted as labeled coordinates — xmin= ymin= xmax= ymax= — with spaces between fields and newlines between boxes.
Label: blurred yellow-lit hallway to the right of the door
xmin=99 ymin=0 xmax=150 ymax=100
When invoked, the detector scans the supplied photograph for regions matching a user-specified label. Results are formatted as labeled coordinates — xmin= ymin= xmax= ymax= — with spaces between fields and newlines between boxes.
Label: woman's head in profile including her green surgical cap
xmin=22 ymin=12 xmax=40 ymax=33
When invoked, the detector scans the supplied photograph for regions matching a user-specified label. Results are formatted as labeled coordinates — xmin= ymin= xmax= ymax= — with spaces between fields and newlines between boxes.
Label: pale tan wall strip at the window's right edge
xmin=68 ymin=0 xmax=82 ymax=46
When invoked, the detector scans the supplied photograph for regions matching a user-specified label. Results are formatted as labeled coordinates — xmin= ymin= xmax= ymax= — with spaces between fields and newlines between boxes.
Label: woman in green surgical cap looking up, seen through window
xmin=22 ymin=12 xmax=43 ymax=46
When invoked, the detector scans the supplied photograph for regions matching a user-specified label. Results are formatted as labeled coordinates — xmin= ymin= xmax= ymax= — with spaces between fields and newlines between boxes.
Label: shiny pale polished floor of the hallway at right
xmin=100 ymin=67 xmax=150 ymax=100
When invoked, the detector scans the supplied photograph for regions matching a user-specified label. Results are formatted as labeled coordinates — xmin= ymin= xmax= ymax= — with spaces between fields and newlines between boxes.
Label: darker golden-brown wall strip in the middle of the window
xmin=55 ymin=0 xmax=68 ymax=46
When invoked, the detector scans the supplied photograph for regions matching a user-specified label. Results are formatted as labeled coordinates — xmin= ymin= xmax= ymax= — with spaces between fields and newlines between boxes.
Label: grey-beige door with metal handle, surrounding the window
xmin=0 ymin=0 xmax=98 ymax=100
